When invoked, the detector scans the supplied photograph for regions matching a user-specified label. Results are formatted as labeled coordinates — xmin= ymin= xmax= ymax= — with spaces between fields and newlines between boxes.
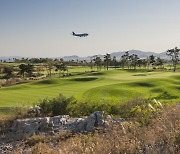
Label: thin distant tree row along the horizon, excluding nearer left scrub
xmin=5 ymin=47 xmax=177 ymax=71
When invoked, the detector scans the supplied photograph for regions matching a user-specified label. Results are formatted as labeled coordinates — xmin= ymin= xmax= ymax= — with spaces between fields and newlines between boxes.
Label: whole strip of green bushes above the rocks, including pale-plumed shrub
xmin=39 ymin=94 xmax=163 ymax=125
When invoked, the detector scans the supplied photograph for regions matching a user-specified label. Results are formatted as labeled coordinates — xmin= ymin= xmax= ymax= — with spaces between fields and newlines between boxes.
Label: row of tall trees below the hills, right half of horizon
xmin=91 ymin=47 xmax=180 ymax=71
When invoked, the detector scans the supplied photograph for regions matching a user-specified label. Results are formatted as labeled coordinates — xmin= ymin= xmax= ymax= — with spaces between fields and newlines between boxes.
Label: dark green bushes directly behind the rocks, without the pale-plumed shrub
xmin=39 ymin=94 xmax=119 ymax=116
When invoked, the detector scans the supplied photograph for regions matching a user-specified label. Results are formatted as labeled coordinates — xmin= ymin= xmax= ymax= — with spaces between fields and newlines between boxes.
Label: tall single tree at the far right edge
xmin=166 ymin=47 xmax=180 ymax=72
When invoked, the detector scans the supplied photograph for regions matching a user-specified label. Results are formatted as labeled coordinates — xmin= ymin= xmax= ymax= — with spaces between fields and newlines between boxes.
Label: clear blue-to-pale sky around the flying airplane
xmin=0 ymin=0 xmax=180 ymax=57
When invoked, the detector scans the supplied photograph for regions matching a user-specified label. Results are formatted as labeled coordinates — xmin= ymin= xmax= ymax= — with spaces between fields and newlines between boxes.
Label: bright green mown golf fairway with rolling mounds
xmin=0 ymin=68 xmax=180 ymax=107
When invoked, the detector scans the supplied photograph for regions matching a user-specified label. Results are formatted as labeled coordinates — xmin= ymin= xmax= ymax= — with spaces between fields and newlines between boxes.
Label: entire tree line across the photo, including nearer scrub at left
xmin=0 ymin=47 xmax=180 ymax=79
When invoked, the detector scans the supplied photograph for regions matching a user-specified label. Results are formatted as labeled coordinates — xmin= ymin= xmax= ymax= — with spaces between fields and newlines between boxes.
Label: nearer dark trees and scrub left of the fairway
xmin=0 ymin=59 xmax=68 ymax=79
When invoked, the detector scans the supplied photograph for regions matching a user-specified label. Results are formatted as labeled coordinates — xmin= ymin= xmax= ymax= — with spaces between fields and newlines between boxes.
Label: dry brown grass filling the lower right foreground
xmin=10 ymin=104 xmax=180 ymax=154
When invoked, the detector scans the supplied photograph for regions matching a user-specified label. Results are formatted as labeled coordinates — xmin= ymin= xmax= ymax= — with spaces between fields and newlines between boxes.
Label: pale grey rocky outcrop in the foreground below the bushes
xmin=11 ymin=111 xmax=122 ymax=136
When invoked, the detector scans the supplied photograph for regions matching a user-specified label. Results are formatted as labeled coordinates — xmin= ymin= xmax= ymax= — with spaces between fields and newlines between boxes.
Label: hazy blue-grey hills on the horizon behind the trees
xmin=0 ymin=50 xmax=169 ymax=61
